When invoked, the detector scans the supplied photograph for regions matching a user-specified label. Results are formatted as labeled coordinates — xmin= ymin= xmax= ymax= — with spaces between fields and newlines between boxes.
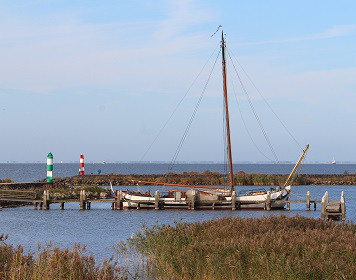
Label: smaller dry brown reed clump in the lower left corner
xmin=0 ymin=235 xmax=127 ymax=280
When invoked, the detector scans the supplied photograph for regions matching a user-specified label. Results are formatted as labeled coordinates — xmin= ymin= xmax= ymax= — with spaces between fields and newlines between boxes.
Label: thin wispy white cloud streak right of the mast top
xmin=238 ymin=24 xmax=356 ymax=46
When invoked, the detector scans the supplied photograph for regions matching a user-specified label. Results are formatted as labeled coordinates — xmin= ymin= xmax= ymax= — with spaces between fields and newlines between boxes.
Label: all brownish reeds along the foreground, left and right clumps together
xmin=0 ymin=216 xmax=356 ymax=280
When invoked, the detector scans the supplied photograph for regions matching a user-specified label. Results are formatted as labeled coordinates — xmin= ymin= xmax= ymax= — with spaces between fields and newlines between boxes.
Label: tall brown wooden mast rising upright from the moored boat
xmin=221 ymin=31 xmax=235 ymax=192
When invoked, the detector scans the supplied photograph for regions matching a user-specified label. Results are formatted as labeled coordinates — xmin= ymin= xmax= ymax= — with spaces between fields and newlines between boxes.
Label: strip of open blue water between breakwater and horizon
xmin=0 ymin=163 xmax=356 ymax=182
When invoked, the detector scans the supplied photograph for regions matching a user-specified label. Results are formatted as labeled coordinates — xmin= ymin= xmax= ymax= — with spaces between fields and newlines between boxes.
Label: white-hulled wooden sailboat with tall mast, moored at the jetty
xmin=123 ymin=32 xmax=309 ymax=209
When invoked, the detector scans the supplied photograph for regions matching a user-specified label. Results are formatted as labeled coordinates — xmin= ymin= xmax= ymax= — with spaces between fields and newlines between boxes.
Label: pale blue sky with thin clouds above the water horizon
xmin=0 ymin=0 xmax=356 ymax=162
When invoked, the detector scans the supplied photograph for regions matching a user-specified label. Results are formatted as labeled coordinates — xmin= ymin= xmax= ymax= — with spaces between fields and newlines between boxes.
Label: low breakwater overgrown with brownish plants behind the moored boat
xmin=45 ymin=171 xmax=356 ymax=188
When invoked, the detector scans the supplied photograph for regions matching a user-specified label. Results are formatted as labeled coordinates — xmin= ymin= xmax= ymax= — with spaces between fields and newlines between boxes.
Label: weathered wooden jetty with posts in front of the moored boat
xmin=0 ymin=190 xmax=346 ymax=221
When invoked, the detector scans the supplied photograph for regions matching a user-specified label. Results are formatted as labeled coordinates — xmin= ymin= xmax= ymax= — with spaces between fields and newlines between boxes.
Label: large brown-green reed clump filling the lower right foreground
xmin=125 ymin=216 xmax=356 ymax=279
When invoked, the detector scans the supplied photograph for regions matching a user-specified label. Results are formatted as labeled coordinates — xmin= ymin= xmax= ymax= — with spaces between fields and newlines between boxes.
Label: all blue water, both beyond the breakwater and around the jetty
xmin=0 ymin=163 xmax=356 ymax=259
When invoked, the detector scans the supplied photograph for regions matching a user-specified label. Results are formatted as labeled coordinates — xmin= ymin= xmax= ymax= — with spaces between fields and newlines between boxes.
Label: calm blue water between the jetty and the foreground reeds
xmin=0 ymin=186 xmax=356 ymax=260
